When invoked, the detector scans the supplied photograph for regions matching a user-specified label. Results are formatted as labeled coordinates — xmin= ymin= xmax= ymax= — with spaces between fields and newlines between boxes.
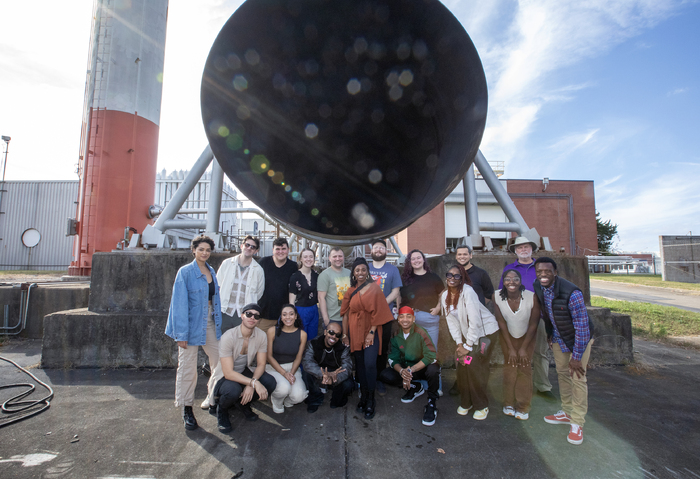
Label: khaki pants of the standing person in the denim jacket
xmin=175 ymin=305 xmax=224 ymax=407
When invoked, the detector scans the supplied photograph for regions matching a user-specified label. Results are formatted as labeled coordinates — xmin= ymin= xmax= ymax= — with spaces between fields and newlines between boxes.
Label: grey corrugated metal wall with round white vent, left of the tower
xmin=0 ymin=181 xmax=78 ymax=270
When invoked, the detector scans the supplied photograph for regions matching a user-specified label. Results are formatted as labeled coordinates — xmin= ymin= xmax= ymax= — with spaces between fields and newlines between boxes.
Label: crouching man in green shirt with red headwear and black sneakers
xmin=379 ymin=306 xmax=440 ymax=426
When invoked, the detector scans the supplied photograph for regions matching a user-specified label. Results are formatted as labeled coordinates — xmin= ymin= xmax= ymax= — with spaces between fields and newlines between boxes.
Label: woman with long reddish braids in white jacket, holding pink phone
xmin=440 ymin=264 xmax=498 ymax=421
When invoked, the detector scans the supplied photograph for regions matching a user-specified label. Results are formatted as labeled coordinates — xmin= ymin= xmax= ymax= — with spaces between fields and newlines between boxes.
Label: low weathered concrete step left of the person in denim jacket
xmin=41 ymin=309 xmax=177 ymax=368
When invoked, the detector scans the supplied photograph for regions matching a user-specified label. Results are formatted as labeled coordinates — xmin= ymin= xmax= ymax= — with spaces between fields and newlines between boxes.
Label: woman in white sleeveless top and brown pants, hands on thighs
xmin=494 ymin=269 xmax=540 ymax=421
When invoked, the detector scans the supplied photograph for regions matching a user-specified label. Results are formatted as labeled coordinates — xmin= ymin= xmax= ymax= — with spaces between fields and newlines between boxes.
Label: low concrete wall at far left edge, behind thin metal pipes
xmin=0 ymin=283 xmax=90 ymax=339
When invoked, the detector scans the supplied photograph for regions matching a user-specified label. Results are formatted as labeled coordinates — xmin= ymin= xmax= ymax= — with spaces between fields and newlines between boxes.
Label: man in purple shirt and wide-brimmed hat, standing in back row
xmin=498 ymin=236 xmax=556 ymax=400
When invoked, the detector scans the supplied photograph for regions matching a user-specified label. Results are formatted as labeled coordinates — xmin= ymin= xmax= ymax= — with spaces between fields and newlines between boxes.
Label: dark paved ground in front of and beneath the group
xmin=0 ymin=341 xmax=700 ymax=479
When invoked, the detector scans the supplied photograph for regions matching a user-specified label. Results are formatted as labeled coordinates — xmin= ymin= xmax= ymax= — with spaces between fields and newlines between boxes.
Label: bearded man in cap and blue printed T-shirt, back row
xmin=369 ymin=239 xmax=403 ymax=396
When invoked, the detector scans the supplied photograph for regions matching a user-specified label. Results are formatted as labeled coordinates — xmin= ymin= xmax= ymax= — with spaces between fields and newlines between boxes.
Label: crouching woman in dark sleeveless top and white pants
xmin=265 ymin=304 xmax=309 ymax=414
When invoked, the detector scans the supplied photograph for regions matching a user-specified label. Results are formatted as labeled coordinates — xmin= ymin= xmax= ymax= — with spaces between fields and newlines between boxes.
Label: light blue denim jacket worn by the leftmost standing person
xmin=165 ymin=260 xmax=221 ymax=346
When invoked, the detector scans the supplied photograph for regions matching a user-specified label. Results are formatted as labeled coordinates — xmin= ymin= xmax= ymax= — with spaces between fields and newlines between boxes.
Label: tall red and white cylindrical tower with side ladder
xmin=69 ymin=0 xmax=168 ymax=276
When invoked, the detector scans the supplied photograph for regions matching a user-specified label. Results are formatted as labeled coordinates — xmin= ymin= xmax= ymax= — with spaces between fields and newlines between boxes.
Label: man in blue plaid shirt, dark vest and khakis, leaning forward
xmin=534 ymin=258 xmax=593 ymax=444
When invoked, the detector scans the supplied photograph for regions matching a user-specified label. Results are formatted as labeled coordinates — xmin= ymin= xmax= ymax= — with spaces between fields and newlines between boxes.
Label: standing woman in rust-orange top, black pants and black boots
xmin=340 ymin=258 xmax=394 ymax=419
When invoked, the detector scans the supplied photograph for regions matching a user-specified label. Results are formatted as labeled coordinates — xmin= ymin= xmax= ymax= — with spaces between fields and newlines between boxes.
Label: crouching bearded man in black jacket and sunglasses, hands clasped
xmin=302 ymin=321 xmax=354 ymax=413
